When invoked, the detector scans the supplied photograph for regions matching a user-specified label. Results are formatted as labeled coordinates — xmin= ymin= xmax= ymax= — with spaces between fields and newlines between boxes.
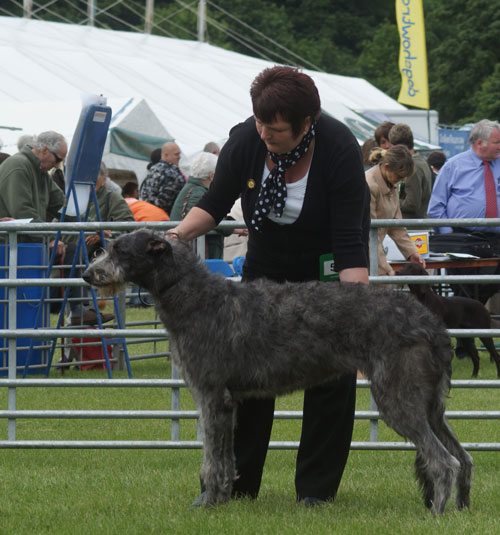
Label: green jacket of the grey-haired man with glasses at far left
xmin=0 ymin=147 xmax=64 ymax=223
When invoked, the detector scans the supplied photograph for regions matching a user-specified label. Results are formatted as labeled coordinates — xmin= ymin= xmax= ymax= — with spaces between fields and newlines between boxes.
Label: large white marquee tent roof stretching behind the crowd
xmin=0 ymin=17 xmax=436 ymax=179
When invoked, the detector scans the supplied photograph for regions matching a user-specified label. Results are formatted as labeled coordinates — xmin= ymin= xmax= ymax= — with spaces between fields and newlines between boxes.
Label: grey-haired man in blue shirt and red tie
xmin=427 ymin=119 xmax=500 ymax=356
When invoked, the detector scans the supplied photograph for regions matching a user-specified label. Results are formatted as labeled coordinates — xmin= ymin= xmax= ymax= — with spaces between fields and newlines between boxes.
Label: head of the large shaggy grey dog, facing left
xmin=82 ymin=229 xmax=173 ymax=295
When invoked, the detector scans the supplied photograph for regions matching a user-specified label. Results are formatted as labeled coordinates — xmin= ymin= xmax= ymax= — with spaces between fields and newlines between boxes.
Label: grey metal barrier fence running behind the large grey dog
xmin=0 ymin=219 xmax=500 ymax=451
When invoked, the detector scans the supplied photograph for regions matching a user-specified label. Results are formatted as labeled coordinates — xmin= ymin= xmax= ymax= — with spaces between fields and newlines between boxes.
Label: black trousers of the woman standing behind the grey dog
xmin=227 ymin=264 xmax=356 ymax=500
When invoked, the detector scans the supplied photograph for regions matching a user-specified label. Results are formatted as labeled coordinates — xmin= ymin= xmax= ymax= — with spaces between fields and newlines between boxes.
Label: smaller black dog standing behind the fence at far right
xmin=397 ymin=263 xmax=500 ymax=378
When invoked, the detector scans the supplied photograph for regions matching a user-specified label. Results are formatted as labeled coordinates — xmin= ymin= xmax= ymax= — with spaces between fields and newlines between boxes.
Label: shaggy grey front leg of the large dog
xmin=200 ymin=393 xmax=236 ymax=506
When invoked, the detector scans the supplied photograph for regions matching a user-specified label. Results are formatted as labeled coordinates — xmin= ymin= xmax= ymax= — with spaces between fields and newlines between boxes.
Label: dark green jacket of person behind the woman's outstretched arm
xmin=170 ymin=176 xmax=233 ymax=258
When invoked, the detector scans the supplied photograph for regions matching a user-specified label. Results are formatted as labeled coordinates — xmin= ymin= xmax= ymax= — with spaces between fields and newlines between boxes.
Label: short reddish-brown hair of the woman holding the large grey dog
xmin=250 ymin=66 xmax=321 ymax=136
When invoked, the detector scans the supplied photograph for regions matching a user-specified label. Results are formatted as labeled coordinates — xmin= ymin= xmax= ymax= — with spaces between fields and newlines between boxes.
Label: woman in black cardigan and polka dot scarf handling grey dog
xmin=169 ymin=66 xmax=370 ymax=505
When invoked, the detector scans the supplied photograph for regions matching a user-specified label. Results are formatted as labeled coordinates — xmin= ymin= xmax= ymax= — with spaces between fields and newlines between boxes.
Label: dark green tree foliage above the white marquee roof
xmin=18 ymin=0 xmax=500 ymax=124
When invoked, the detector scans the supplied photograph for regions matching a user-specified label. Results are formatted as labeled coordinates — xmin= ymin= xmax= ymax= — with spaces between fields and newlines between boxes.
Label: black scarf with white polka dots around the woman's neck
xmin=251 ymin=122 xmax=316 ymax=232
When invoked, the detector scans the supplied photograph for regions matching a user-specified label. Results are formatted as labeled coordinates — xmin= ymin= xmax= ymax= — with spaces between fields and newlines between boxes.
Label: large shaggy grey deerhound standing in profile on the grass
xmin=83 ymin=230 xmax=472 ymax=514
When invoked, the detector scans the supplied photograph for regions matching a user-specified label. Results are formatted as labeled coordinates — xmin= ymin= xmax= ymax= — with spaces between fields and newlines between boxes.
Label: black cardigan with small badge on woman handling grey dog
xmin=198 ymin=115 xmax=370 ymax=272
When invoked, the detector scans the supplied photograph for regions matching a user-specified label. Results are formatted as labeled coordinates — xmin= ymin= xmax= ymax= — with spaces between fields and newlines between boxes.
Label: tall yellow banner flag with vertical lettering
xmin=396 ymin=0 xmax=429 ymax=110
